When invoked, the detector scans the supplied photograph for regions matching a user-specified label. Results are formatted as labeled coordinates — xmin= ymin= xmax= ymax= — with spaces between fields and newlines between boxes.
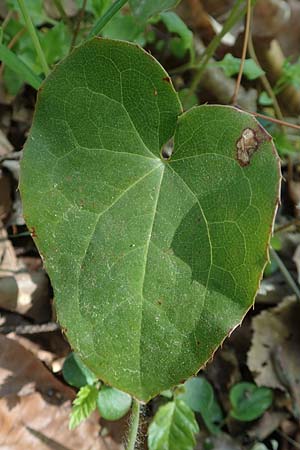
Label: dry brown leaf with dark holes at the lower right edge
xmin=248 ymin=297 xmax=300 ymax=418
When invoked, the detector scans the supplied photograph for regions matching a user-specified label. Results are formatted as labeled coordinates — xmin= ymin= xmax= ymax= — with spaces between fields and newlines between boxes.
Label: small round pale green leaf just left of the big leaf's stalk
xmin=97 ymin=386 xmax=132 ymax=420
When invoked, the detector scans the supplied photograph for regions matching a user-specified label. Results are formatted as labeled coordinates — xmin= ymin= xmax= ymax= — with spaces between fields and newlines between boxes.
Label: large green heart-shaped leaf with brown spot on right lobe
xmin=21 ymin=39 xmax=280 ymax=401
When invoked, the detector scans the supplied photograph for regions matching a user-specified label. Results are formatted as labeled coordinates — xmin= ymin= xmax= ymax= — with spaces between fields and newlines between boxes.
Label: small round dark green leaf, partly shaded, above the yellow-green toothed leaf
xmin=62 ymin=352 xmax=97 ymax=388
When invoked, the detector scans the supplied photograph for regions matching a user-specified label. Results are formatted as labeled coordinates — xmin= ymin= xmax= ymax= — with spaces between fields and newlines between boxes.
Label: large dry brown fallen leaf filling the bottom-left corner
xmin=0 ymin=335 xmax=122 ymax=450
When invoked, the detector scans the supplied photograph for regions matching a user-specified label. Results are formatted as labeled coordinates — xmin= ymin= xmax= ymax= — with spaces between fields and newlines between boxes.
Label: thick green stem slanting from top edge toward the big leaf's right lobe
xmin=187 ymin=0 xmax=246 ymax=98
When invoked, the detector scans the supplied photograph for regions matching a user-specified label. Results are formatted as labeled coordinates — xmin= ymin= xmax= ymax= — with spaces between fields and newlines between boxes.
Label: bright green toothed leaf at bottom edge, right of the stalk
xmin=148 ymin=399 xmax=199 ymax=450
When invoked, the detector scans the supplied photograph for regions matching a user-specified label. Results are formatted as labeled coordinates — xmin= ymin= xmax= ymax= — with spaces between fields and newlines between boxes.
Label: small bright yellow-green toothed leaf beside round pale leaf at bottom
xmin=69 ymin=385 xmax=98 ymax=430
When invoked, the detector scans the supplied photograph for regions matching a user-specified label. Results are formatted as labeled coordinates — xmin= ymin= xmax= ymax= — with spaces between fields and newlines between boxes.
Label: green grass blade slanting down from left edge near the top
xmin=0 ymin=44 xmax=43 ymax=89
